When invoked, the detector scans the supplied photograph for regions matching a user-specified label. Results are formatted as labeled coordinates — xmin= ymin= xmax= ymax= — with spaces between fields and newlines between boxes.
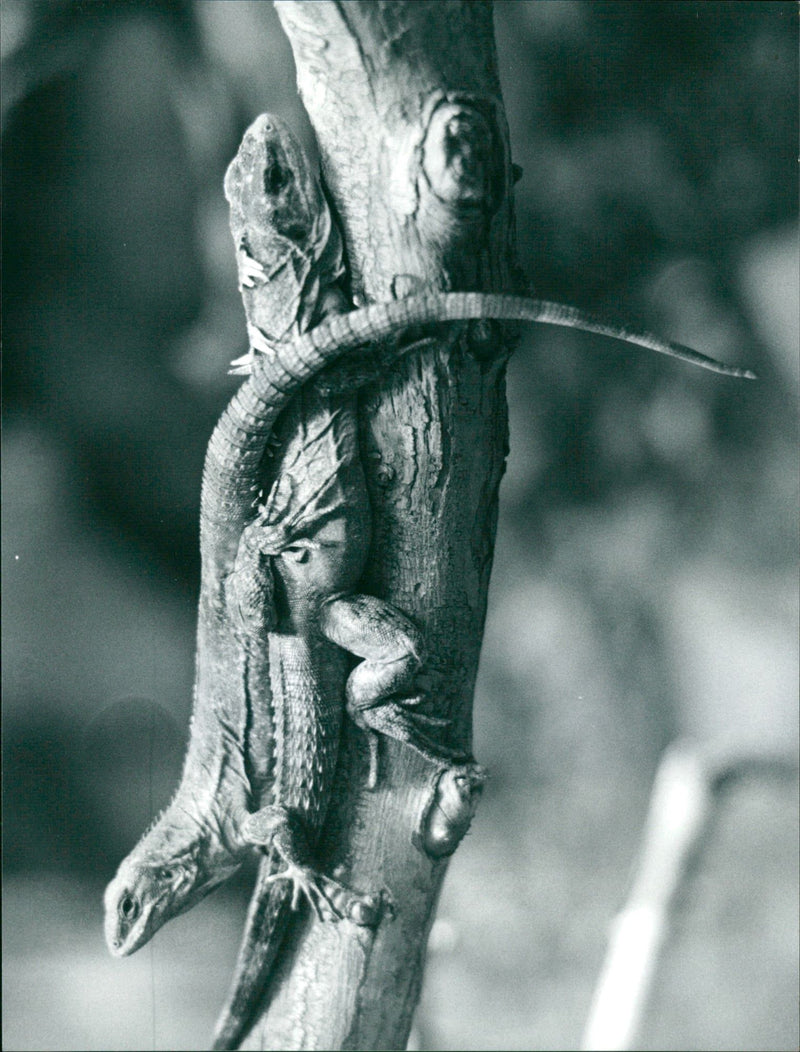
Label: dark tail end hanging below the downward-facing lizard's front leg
xmin=212 ymin=852 xmax=292 ymax=1052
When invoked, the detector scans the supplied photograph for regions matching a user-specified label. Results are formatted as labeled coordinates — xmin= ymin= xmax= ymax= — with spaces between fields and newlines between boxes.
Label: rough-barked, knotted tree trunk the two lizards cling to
xmin=242 ymin=6 xmax=518 ymax=1049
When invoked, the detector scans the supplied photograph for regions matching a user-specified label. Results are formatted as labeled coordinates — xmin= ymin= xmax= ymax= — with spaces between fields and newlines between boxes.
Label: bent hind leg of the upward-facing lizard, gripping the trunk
xmin=319 ymin=594 xmax=464 ymax=789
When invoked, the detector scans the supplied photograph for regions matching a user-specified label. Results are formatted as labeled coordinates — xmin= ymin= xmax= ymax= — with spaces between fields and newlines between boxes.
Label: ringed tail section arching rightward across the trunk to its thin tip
xmin=279 ymin=292 xmax=756 ymax=380
